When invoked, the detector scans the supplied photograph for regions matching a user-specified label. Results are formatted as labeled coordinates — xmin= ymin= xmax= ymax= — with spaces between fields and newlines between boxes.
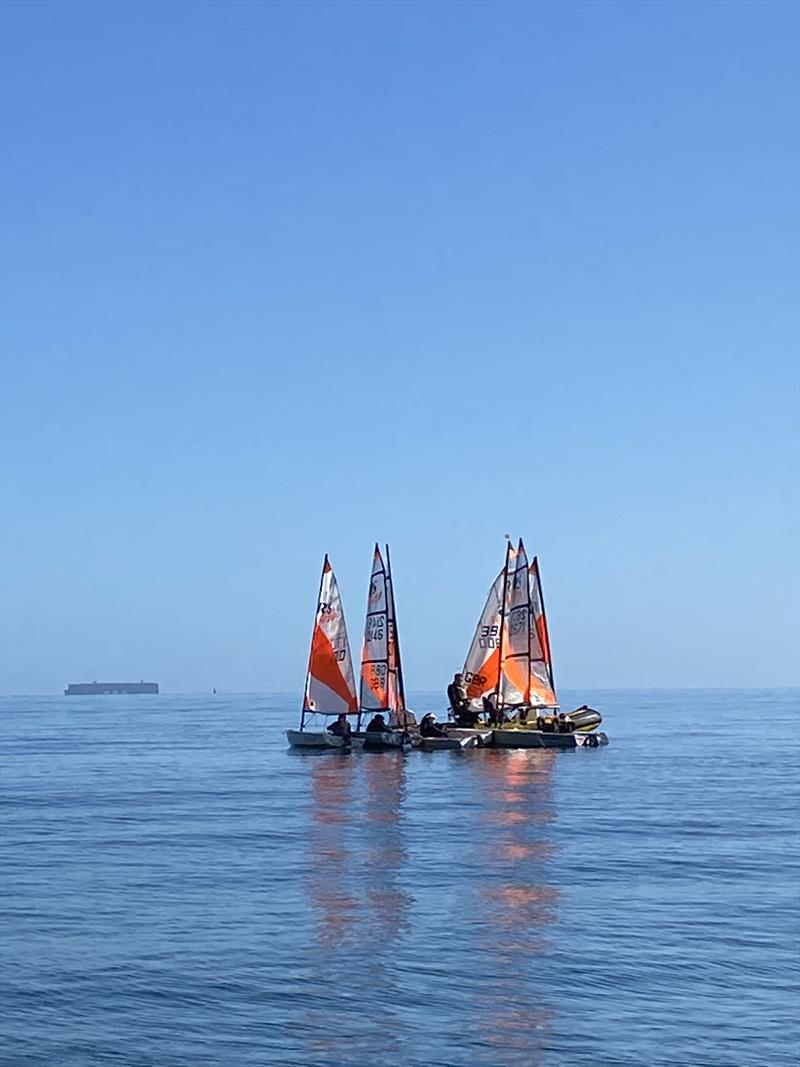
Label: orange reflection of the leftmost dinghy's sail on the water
xmin=308 ymin=753 xmax=358 ymax=947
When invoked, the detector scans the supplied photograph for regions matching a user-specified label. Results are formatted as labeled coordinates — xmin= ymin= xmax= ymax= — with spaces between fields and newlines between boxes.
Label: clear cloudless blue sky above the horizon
xmin=2 ymin=0 xmax=800 ymax=692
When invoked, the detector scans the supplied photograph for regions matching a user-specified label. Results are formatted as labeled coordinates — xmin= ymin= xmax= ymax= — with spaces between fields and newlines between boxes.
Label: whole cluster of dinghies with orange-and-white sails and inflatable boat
xmin=286 ymin=539 xmax=608 ymax=751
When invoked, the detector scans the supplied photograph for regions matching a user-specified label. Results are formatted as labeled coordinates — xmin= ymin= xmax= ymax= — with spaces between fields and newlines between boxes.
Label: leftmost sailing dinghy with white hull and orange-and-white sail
xmin=286 ymin=556 xmax=358 ymax=749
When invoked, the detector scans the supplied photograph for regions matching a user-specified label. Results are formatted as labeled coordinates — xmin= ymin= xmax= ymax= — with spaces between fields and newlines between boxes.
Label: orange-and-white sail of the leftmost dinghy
xmin=303 ymin=556 xmax=358 ymax=715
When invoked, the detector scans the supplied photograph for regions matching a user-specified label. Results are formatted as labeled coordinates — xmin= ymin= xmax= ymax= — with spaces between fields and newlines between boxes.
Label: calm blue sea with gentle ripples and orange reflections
xmin=0 ymin=690 xmax=800 ymax=1067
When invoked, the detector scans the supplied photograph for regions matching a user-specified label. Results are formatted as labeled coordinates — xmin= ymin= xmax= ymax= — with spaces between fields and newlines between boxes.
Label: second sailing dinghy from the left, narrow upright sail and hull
xmin=358 ymin=544 xmax=413 ymax=751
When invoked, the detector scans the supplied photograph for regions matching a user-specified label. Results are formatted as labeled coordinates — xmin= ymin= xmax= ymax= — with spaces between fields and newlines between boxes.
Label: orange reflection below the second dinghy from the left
xmin=362 ymin=752 xmax=414 ymax=937
